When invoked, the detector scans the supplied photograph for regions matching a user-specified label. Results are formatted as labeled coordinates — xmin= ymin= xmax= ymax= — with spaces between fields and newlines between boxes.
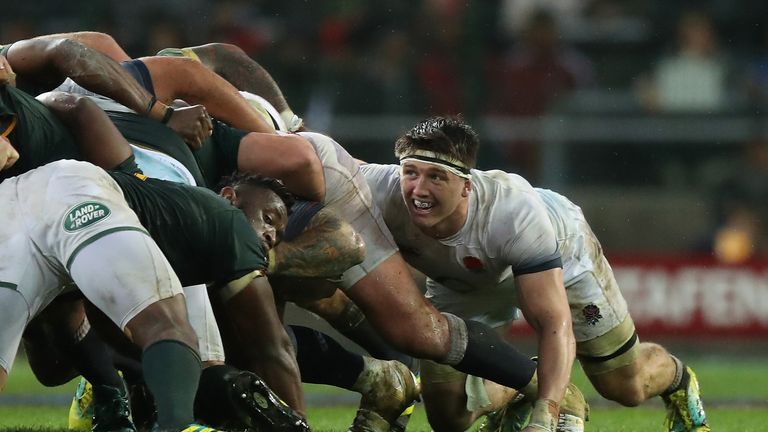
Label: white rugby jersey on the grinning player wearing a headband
xmin=362 ymin=164 xmax=578 ymax=325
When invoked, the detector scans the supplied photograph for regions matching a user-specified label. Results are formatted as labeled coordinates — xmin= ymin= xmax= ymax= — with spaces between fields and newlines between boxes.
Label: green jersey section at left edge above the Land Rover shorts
xmin=0 ymin=86 xmax=80 ymax=180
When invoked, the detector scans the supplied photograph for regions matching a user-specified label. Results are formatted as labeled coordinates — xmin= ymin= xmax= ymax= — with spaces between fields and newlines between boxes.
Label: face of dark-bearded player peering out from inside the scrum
xmin=240 ymin=188 xmax=288 ymax=249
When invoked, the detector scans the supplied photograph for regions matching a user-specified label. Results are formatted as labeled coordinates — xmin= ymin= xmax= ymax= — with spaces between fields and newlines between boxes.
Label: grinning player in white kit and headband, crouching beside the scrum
xmin=362 ymin=117 xmax=709 ymax=431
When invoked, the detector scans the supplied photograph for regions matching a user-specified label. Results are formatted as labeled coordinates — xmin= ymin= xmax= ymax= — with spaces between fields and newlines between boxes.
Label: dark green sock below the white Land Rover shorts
xmin=142 ymin=339 xmax=201 ymax=429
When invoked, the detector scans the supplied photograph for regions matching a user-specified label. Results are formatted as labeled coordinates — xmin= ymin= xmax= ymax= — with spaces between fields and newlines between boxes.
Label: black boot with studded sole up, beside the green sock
xmin=195 ymin=368 xmax=310 ymax=432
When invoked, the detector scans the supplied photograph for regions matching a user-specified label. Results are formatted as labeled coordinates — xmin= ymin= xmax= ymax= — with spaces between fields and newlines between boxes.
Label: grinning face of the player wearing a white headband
xmin=400 ymin=161 xmax=470 ymax=237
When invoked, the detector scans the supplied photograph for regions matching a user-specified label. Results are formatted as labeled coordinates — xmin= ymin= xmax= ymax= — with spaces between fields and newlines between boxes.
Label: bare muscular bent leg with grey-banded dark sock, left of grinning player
xmin=348 ymin=253 xmax=536 ymax=390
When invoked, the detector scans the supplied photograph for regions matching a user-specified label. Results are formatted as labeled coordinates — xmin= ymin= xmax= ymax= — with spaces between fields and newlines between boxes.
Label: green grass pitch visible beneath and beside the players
xmin=0 ymin=357 xmax=768 ymax=432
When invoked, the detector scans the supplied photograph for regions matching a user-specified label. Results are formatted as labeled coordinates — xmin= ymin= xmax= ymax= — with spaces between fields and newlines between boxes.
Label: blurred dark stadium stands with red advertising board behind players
xmin=0 ymin=0 xmax=768 ymax=428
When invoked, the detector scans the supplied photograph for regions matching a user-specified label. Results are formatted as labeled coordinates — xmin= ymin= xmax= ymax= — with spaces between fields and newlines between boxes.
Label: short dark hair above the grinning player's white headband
xmin=395 ymin=116 xmax=480 ymax=168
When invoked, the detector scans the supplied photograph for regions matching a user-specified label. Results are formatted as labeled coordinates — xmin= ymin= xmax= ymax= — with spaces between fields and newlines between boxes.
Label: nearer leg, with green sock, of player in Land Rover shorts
xmin=70 ymin=231 xmax=200 ymax=428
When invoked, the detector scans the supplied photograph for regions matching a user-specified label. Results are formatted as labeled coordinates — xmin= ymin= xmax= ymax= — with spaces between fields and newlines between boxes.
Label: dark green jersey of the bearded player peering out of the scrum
xmin=110 ymin=171 xmax=268 ymax=286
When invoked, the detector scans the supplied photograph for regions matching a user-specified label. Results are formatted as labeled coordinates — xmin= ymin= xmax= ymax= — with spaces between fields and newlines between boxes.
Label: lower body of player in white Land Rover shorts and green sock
xmin=0 ymin=157 xmax=210 ymax=430
